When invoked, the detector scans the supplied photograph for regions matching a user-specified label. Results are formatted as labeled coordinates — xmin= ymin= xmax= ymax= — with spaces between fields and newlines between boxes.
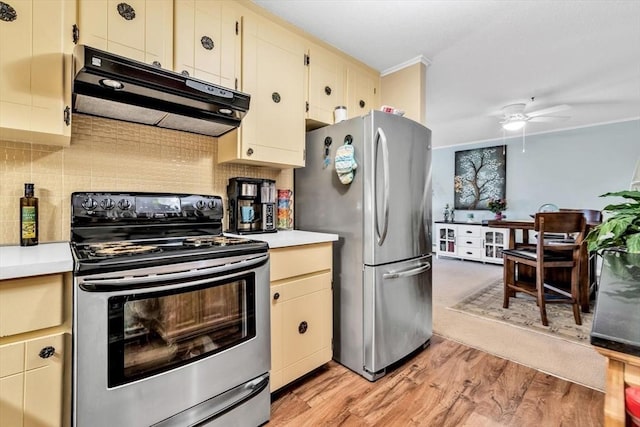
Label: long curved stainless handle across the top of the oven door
xmin=80 ymin=254 xmax=269 ymax=291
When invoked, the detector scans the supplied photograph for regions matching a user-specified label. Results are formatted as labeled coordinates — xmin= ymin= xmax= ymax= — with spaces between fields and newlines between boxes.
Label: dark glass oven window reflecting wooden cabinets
xmin=108 ymin=274 xmax=256 ymax=387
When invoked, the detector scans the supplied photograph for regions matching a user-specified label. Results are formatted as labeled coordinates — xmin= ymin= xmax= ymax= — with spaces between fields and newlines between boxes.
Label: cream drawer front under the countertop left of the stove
xmin=0 ymin=274 xmax=64 ymax=337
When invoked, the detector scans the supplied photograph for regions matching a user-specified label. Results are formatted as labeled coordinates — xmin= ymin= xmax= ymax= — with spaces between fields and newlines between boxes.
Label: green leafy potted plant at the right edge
xmin=585 ymin=190 xmax=640 ymax=253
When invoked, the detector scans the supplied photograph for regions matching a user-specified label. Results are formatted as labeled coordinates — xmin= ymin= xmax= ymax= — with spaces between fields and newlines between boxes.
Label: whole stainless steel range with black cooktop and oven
xmin=71 ymin=193 xmax=271 ymax=427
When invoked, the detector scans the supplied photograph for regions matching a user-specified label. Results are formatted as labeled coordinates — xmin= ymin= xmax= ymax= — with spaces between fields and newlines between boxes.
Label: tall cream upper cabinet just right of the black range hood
xmin=218 ymin=10 xmax=305 ymax=167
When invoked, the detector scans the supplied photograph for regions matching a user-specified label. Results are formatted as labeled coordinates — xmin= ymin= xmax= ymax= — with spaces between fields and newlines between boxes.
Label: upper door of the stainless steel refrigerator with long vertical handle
xmin=362 ymin=111 xmax=431 ymax=265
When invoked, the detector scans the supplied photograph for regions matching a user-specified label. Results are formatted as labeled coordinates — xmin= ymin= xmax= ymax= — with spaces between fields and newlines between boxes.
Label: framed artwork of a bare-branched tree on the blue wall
xmin=454 ymin=145 xmax=507 ymax=210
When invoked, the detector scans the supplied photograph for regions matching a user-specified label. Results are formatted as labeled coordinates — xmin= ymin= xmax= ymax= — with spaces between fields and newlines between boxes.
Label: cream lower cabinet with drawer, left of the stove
xmin=0 ymin=274 xmax=71 ymax=427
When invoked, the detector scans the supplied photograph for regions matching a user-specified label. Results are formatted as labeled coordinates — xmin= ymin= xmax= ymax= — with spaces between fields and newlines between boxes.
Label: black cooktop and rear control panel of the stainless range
xmin=71 ymin=193 xmax=269 ymax=272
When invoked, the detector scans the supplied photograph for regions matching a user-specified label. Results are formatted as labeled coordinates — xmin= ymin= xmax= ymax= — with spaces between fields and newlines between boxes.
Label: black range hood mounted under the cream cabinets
xmin=73 ymin=45 xmax=251 ymax=136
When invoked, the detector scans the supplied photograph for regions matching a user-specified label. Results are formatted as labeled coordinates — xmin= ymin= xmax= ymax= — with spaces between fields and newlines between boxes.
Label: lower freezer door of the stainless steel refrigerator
xmin=363 ymin=255 xmax=433 ymax=379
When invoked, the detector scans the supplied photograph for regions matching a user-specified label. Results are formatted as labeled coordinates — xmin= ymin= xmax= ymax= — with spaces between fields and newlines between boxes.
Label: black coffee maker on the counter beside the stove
xmin=227 ymin=177 xmax=277 ymax=234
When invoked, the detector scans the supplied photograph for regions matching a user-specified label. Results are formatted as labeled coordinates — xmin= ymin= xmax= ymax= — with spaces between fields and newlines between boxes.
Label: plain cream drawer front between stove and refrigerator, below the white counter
xmin=269 ymin=242 xmax=332 ymax=282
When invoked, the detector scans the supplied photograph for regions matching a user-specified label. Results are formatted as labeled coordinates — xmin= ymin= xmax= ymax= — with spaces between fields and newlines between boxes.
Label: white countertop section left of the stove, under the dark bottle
xmin=0 ymin=242 xmax=73 ymax=280
